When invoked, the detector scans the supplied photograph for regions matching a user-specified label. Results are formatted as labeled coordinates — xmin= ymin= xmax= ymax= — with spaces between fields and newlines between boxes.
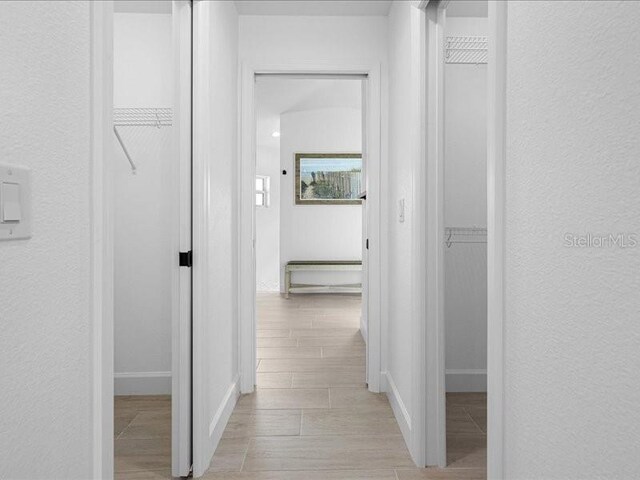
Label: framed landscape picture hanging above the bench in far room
xmin=294 ymin=153 xmax=364 ymax=205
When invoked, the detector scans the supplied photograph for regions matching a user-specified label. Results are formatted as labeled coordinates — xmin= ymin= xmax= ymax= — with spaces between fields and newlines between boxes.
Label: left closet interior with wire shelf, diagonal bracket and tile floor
xmin=112 ymin=1 xmax=176 ymax=478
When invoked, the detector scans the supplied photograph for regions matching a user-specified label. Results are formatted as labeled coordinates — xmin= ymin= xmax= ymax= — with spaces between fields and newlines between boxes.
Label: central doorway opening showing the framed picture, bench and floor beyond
xmin=255 ymin=76 xmax=367 ymax=393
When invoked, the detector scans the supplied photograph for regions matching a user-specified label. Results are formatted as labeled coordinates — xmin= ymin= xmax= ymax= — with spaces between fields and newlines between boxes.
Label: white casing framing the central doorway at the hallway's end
xmin=239 ymin=65 xmax=383 ymax=393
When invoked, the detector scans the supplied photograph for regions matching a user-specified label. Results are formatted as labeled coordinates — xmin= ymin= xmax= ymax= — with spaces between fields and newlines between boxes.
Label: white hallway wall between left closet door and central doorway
xmin=194 ymin=2 xmax=239 ymax=476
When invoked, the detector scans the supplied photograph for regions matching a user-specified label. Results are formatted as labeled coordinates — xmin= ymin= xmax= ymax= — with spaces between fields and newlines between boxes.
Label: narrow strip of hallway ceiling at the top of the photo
xmin=235 ymin=0 xmax=391 ymax=16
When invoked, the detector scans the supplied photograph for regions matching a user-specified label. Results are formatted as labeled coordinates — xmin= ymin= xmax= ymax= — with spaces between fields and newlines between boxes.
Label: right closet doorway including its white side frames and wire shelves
xmin=424 ymin=1 xmax=506 ymax=478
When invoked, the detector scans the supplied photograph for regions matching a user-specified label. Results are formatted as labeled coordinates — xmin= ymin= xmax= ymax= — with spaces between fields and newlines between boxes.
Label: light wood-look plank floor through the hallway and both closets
xmin=115 ymin=294 xmax=486 ymax=480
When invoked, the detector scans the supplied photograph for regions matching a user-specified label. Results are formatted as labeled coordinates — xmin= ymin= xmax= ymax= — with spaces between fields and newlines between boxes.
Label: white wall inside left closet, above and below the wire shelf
xmin=113 ymin=13 xmax=172 ymax=395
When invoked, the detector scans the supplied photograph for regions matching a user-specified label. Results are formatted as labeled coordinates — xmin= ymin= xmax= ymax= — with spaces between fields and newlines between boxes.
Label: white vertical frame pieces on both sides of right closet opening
xmin=412 ymin=0 xmax=508 ymax=474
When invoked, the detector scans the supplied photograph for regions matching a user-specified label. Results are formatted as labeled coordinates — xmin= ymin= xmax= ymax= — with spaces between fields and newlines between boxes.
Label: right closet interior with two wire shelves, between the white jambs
xmin=444 ymin=2 xmax=487 ymax=467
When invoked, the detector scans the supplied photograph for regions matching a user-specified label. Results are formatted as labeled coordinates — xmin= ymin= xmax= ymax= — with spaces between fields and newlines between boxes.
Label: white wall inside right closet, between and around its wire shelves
xmin=444 ymin=17 xmax=487 ymax=392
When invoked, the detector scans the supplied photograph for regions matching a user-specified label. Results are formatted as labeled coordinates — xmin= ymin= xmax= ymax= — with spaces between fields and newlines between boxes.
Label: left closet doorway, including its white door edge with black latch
xmin=109 ymin=1 xmax=192 ymax=477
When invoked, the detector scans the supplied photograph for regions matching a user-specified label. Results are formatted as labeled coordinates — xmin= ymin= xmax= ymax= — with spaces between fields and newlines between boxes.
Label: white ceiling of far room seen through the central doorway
xmin=256 ymin=77 xmax=362 ymax=147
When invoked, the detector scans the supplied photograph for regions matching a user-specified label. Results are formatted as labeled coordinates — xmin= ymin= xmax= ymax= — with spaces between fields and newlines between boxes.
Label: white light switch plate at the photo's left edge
xmin=0 ymin=164 xmax=31 ymax=240
